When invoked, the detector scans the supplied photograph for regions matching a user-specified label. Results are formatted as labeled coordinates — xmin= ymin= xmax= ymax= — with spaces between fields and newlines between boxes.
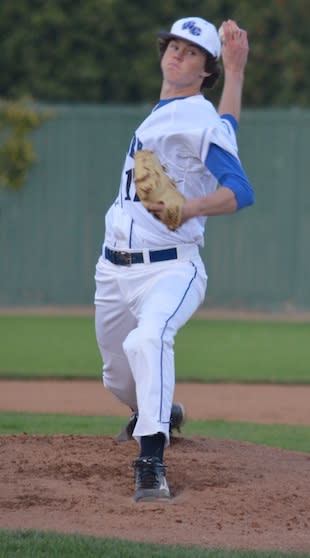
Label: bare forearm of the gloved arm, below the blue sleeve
xmin=183 ymin=186 xmax=238 ymax=222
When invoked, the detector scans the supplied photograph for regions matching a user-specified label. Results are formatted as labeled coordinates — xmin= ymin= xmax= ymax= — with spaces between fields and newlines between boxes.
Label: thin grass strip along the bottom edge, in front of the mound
xmin=0 ymin=530 xmax=309 ymax=558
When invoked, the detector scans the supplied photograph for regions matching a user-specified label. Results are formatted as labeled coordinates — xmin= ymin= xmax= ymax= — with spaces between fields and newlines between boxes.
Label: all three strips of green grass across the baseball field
xmin=0 ymin=316 xmax=310 ymax=558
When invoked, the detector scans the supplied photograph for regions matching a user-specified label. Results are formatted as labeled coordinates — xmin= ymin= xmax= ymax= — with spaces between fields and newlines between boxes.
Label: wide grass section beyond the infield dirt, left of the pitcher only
xmin=0 ymin=316 xmax=102 ymax=379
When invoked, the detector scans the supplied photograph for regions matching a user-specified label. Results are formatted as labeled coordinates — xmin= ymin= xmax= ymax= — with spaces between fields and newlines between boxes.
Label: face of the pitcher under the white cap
xmin=161 ymin=39 xmax=209 ymax=90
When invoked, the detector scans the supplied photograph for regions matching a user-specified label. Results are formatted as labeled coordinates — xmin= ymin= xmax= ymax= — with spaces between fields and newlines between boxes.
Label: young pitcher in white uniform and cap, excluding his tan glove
xmin=95 ymin=17 xmax=254 ymax=501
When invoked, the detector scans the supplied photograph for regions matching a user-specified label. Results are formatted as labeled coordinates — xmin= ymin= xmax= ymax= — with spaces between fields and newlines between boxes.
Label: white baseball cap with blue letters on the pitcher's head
xmin=157 ymin=17 xmax=221 ymax=58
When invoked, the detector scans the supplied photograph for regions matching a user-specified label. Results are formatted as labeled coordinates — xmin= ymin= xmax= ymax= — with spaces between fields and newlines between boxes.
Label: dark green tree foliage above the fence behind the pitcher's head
xmin=0 ymin=0 xmax=310 ymax=107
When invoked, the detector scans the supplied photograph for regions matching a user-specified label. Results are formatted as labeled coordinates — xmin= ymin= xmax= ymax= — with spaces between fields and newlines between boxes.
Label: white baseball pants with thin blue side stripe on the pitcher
xmin=95 ymin=246 xmax=207 ymax=445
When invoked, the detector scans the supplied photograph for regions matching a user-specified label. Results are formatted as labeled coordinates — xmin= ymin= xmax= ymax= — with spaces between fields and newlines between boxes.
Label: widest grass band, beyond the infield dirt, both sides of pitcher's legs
xmin=0 ymin=316 xmax=310 ymax=384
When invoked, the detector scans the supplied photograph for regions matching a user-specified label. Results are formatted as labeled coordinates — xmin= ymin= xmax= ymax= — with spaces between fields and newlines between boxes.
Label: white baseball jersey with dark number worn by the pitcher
xmin=106 ymin=94 xmax=238 ymax=249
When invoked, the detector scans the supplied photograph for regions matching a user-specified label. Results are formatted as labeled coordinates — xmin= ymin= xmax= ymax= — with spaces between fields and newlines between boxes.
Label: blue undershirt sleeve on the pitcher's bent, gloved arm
xmin=205 ymin=143 xmax=255 ymax=209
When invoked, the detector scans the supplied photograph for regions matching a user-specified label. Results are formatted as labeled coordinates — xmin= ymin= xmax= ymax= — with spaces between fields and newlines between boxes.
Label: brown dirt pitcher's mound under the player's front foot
xmin=0 ymin=434 xmax=310 ymax=552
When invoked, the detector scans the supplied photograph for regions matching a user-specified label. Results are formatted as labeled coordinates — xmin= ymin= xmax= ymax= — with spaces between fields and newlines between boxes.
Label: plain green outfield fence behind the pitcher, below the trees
xmin=0 ymin=105 xmax=310 ymax=311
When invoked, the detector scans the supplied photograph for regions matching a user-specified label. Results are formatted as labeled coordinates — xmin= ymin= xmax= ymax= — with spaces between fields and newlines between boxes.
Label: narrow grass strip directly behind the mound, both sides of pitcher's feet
xmin=0 ymin=413 xmax=310 ymax=452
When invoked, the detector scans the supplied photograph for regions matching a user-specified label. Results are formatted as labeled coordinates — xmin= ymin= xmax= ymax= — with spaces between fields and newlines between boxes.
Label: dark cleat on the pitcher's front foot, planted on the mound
xmin=133 ymin=457 xmax=170 ymax=502
